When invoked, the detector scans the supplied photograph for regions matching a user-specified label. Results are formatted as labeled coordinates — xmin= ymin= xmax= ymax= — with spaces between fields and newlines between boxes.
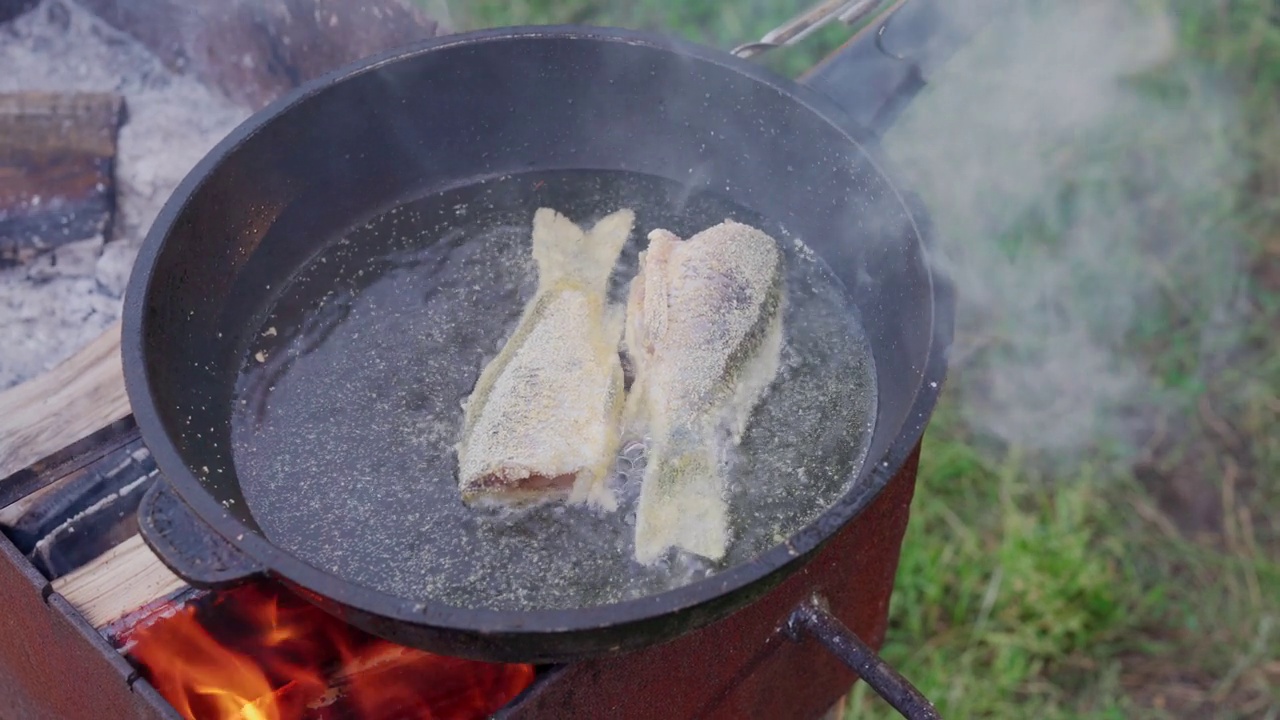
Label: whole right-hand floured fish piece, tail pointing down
xmin=623 ymin=220 xmax=785 ymax=565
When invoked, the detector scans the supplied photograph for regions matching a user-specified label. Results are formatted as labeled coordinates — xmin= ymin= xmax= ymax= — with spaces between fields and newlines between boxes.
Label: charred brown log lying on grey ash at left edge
xmin=0 ymin=92 xmax=124 ymax=264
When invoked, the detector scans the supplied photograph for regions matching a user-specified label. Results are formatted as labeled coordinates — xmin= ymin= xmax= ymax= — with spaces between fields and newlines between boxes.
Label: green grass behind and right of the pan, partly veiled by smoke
xmin=451 ymin=0 xmax=1280 ymax=719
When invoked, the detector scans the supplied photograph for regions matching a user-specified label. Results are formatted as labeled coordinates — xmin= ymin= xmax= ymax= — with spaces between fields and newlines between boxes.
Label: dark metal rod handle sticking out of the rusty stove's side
xmin=786 ymin=596 xmax=942 ymax=720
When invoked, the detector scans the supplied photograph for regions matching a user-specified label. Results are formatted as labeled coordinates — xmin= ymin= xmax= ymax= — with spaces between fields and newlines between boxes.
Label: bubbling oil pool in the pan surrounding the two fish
xmin=232 ymin=170 xmax=877 ymax=610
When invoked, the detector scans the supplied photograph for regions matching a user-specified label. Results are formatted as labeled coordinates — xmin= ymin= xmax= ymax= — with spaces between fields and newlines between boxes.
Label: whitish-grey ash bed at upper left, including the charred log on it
xmin=0 ymin=0 xmax=247 ymax=388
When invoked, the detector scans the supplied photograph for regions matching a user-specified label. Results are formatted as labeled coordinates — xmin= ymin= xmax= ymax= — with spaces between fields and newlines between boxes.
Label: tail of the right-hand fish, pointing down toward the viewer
xmin=635 ymin=430 xmax=728 ymax=565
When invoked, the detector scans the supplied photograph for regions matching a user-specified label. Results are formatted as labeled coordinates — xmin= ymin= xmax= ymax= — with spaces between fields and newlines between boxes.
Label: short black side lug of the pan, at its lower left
xmin=138 ymin=477 xmax=265 ymax=588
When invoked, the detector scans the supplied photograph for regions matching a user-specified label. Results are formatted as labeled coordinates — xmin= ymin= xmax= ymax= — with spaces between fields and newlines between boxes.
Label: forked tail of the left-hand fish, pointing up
xmin=534 ymin=208 xmax=635 ymax=290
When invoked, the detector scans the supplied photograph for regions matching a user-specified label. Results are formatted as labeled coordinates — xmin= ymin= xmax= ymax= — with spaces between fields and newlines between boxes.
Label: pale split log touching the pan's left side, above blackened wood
xmin=0 ymin=323 xmax=129 ymax=478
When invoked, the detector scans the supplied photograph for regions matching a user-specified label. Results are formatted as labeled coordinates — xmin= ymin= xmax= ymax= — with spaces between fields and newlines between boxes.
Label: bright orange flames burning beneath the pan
xmin=122 ymin=583 xmax=534 ymax=720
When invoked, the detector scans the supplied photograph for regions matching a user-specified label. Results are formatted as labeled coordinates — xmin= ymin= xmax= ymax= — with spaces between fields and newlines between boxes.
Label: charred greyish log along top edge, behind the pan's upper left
xmin=81 ymin=0 xmax=436 ymax=108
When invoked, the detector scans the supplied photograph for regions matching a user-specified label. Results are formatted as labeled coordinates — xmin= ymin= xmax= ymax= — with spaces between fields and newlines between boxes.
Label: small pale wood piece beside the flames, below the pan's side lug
xmin=52 ymin=536 xmax=188 ymax=628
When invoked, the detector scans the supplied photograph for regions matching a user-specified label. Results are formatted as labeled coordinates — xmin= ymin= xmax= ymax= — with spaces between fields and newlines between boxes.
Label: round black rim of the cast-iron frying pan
xmin=122 ymin=26 xmax=946 ymax=655
